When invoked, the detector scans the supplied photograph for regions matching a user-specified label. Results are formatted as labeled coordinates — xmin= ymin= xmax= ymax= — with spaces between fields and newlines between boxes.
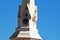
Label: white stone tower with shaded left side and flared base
xmin=10 ymin=0 xmax=42 ymax=40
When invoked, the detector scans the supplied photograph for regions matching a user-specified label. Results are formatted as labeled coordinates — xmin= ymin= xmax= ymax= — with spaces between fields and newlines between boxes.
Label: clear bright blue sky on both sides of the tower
xmin=0 ymin=0 xmax=60 ymax=40
